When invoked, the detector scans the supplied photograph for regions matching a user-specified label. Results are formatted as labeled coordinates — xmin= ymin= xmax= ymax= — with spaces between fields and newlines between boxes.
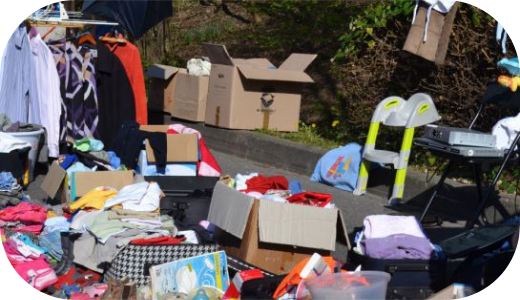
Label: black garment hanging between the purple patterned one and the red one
xmin=95 ymin=43 xmax=136 ymax=145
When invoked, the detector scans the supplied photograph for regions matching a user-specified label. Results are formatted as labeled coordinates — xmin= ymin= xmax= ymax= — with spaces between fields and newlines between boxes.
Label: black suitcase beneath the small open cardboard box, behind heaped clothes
xmin=145 ymin=176 xmax=219 ymax=230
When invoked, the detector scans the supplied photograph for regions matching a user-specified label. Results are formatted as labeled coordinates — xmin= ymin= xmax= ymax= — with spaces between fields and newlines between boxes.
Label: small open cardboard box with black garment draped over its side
xmin=139 ymin=125 xmax=199 ymax=164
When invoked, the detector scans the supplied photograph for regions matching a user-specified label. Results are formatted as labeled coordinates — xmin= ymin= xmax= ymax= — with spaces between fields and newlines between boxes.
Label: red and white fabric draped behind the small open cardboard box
xmin=168 ymin=124 xmax=222 ymax=177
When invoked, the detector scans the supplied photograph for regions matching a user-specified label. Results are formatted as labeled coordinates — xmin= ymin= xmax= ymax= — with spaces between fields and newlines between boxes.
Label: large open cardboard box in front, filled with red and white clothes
xmin=208 ymin=182 xmax=350 ymax=274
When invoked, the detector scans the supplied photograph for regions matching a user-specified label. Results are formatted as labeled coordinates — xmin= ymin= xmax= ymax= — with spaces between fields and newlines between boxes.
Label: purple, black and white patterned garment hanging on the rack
xmin=48 ymin=40 xmax=99 ymax=142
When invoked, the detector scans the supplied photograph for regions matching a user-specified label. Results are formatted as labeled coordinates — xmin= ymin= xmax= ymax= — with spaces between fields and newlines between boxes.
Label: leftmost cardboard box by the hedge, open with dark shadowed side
xmin=145 ymin=64 xmax=186 ymax=113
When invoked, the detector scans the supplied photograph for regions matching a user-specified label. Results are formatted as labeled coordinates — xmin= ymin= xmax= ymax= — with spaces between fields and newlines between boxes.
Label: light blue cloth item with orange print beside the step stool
xmin=310 ymin=143 xmax=363 ymax=192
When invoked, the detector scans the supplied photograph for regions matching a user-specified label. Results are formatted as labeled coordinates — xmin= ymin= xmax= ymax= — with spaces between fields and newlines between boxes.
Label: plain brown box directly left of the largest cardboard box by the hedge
xmin=171 ymin=72 xmax=209 ymax=122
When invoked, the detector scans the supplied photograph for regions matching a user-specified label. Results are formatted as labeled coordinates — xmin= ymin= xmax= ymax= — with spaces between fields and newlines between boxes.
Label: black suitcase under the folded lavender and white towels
xmin=347 ymin=250 xmax=447 ymax=300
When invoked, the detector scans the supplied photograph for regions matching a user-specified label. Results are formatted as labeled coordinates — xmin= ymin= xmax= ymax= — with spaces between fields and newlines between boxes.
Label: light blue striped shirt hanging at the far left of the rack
xmin=0 ymin=23 xmax=40 ymax=124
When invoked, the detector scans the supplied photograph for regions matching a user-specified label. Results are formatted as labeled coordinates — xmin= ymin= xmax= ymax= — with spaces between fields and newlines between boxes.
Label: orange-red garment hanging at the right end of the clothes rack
xmin=104 ymin=35 xmax=148 ymax=125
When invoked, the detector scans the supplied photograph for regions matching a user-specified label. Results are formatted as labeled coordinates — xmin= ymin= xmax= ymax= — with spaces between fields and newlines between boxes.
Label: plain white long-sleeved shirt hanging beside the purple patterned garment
xmin=31 ymin=34 xmax=61 ymax=157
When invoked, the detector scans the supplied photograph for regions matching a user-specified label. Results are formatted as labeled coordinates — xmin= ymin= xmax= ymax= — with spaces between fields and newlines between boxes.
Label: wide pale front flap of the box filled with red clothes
xmin=258 ymin=200 xmax=338 ymax=251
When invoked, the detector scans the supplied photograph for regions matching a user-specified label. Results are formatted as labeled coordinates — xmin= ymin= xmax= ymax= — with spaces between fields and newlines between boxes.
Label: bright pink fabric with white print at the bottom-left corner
xmin=14 ymin=258 xmax=58 ymax=291
